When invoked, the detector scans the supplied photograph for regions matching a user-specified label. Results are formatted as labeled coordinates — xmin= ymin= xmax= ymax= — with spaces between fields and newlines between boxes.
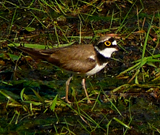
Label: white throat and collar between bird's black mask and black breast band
xmin=95 ymin=46 xmax=117 ymax=58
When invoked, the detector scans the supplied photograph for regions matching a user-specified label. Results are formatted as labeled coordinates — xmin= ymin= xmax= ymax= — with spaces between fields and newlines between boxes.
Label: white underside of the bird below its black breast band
xmin=86 ymin=62 xmax=108 ymax=75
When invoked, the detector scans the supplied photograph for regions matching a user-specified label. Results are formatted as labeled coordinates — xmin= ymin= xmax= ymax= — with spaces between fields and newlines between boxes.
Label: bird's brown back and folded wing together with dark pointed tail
xmin=18 ymin=44 xmax=96 ymax=73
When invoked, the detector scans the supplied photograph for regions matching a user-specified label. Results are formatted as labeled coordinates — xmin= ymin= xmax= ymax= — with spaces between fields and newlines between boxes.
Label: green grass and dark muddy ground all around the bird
xmin=0 ymin=0 xmax=160 ymax=135
